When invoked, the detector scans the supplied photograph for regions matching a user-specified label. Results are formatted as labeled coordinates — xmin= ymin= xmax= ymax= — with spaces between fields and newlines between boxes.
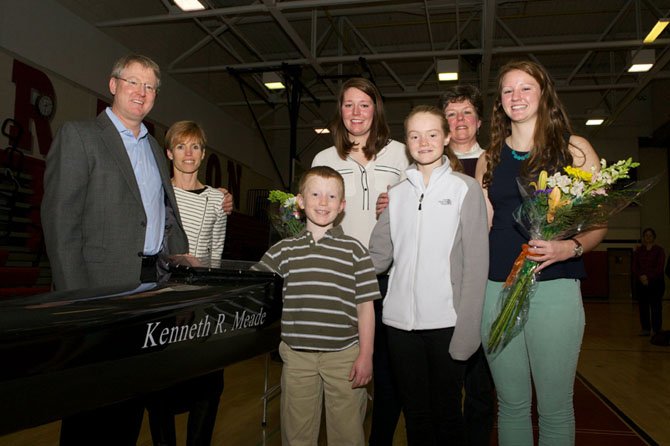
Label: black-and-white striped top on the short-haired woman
xmin=174 ymin=186 xmax=226 ymax=267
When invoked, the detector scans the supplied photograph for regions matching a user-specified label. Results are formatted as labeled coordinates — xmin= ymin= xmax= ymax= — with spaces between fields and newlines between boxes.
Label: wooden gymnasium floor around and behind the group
xmin=0 ymin=301 xmax=670 ymax=446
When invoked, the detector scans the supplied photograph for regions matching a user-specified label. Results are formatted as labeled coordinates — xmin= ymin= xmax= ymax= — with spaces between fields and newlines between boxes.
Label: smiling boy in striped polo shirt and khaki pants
xmin=254 ymin=166 xmax=381 ymax=446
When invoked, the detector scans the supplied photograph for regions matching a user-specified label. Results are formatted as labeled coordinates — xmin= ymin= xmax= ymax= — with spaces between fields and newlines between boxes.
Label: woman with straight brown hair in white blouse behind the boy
xmin=312 ymin=78 xmax=409 ymax=446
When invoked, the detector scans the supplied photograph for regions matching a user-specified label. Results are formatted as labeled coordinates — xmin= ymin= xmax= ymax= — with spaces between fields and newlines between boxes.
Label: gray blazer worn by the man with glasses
xmin=41 ymin=111 xmax=188 ymax=291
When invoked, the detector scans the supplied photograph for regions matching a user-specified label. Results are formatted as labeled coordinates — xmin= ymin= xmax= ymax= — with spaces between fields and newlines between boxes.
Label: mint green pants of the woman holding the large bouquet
xmin=482 ymin=279 xmax=584 ymax=446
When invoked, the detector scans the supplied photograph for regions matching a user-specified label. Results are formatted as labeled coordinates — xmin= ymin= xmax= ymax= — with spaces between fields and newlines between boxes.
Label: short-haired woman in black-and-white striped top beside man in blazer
xmin=147 ymin=121 xmax=226 ymax=446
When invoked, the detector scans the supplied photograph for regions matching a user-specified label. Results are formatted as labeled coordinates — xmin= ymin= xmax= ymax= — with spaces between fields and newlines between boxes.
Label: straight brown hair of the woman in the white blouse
xmin=330 ymin=77 xmax=391 ymax=160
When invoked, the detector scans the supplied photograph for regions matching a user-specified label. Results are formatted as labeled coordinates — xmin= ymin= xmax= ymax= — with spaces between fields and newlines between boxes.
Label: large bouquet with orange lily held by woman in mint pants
xmin=485 ymin=158 xmax=657 ymax=354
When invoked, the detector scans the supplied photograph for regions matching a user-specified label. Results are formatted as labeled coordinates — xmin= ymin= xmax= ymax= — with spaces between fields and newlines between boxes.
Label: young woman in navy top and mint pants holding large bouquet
xmin=476 ymin=61 xmax=606 ymax=446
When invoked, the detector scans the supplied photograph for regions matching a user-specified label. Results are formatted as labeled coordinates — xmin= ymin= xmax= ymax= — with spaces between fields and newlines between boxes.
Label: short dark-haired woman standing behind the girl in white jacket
xmin=440 ymin=85 xmax=495 ymax=446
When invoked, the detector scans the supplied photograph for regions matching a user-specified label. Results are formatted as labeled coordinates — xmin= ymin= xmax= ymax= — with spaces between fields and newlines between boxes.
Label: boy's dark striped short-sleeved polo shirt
xmin=253 ymin=226 xmax=381 ymax=351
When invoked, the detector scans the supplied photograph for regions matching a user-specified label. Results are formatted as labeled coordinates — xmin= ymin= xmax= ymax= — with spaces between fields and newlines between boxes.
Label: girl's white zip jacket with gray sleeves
xmin=370 ymin=157 xmax=489 ymax=360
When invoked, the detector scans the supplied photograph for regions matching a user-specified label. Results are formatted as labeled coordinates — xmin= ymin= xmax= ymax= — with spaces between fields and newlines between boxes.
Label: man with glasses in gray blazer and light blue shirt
xmin=42 ymin=55 xmax=188 ymax=445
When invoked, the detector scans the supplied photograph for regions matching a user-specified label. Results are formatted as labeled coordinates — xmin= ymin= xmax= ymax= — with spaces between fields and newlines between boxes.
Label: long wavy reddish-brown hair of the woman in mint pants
xmin=483 ymin=61 xmax=580 ymax=188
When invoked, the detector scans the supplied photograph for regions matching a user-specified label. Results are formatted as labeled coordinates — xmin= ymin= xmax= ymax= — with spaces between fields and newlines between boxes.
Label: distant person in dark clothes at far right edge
xmin=633 ymin=228 xmax=665 ymax=336
